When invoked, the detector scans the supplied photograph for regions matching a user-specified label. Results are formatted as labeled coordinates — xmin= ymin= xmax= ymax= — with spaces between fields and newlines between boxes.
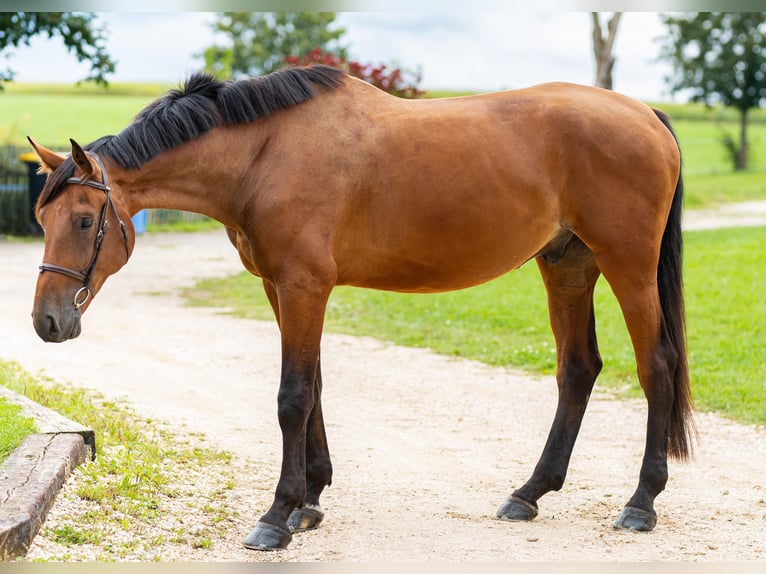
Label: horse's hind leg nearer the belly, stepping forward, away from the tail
xmin=497 ymin=236 xmax=601 ymax=520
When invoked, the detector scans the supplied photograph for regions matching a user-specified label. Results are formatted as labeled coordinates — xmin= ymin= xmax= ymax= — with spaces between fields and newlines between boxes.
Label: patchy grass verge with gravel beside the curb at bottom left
xmin=0 ymin=360 xmax=244 ymax=561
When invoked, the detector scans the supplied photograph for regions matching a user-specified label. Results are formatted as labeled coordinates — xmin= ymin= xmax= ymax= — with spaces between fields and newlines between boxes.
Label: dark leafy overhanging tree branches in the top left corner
xmin=0 ymin=12 xmax=115 ymax=89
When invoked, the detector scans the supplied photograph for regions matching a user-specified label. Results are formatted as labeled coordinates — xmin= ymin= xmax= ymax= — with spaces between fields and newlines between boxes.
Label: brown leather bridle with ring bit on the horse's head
xmin=40 ymin=154 xmax=130 ymax=311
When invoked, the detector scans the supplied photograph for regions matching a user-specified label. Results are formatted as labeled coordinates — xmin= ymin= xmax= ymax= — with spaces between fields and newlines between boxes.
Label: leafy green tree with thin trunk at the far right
xmin=661 ymin=12 xmax=766 ymax=170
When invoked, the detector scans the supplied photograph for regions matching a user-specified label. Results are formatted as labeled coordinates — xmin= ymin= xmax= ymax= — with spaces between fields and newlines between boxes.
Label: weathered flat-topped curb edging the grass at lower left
xmin=0 ymin=385 xmax=96 ymax=560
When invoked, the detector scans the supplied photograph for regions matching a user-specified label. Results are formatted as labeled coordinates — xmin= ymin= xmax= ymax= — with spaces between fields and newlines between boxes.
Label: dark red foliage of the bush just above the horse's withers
xmin=285 ymin=48 xmax=425 ymax=98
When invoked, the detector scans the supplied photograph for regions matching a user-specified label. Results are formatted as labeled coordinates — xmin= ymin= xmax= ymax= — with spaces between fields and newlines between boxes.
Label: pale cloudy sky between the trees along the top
xmin=0 ymin=10 xmax=673 ymax=102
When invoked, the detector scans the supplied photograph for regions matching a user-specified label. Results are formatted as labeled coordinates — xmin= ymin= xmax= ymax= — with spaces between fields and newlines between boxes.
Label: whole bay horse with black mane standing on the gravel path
xmin=30 ymin=66 xmax=695 ymax=550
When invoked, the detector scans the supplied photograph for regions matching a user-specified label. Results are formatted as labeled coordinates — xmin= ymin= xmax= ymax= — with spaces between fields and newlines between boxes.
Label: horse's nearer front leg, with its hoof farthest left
xmin=243 ymin=280 xmax=331 ymax=550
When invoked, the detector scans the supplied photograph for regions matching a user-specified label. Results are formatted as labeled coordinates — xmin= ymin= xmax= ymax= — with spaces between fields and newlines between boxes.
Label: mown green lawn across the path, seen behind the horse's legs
xmin=186 ymin=228 xmax=766 ymax=424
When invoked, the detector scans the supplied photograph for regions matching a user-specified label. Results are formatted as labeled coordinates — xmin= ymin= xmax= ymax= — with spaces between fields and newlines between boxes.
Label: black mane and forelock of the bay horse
xmin=38 ymin=65 xmax=344 ymax=206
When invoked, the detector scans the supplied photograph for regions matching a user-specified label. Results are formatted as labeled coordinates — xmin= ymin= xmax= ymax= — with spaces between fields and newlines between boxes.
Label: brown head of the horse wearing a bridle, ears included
xmin=29 ymin=138 xmax=135 ymax=343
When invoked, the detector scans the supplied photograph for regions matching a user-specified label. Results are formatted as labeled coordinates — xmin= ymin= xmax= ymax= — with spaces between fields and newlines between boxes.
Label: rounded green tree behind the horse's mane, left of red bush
xmin=203 ymin=12 xmax=347 ymax=78
